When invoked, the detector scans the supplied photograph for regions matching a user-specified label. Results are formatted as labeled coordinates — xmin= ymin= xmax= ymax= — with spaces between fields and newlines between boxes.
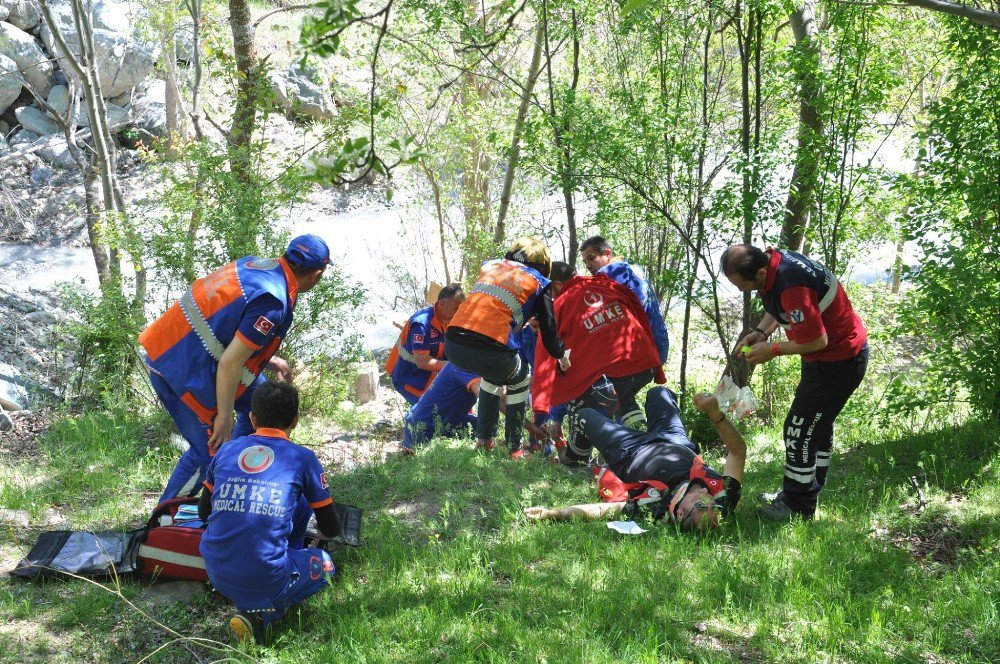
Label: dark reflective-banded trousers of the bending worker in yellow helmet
xmin=444 ymin=338 xmax=531 ymax=452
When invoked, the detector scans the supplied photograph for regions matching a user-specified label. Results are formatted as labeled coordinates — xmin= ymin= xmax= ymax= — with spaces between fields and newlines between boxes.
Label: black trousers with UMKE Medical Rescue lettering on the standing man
xmin=783 ymin=345 xmax=868 ymax=515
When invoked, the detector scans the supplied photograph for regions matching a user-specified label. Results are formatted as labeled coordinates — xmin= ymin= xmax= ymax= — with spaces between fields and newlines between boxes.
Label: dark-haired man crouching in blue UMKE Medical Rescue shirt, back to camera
xmin=198 ymin=382 xmax=341 ymax=642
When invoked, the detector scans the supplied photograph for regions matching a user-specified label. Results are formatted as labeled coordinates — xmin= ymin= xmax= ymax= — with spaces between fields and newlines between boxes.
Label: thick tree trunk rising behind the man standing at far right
xmin=780 ymin=0 xmax=824 ymax=251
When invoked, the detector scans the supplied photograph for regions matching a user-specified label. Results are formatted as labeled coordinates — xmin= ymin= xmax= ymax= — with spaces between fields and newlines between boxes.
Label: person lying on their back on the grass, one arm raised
xmin=524 ymin=387 xmax=746 ymax=530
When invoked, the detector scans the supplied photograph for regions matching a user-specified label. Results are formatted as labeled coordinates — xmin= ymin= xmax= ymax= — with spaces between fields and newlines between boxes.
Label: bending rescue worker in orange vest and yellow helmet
xmin=444 ymin=238 xmax=570 ymax=459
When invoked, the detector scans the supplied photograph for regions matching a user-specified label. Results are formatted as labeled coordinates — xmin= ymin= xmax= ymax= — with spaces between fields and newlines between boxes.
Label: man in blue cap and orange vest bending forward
xmin=139 ymin=235 xmax=330 ymax=503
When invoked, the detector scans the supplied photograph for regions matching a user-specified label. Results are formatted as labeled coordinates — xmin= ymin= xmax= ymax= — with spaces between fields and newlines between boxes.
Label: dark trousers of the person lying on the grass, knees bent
xmin=577 ymin=387 xmax=698 ymax=482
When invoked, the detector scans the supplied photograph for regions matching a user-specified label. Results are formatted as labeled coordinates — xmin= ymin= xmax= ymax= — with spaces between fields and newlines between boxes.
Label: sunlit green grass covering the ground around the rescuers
xmin=0 ymin=402 xmax=1000 ymax=663
